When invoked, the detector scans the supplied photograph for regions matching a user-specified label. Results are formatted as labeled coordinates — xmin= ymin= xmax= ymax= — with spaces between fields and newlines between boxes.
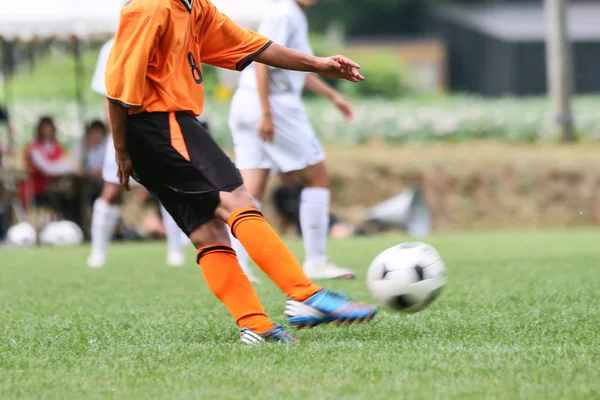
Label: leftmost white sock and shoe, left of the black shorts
xmin=88 ymin=198 xmax=121 ymax=268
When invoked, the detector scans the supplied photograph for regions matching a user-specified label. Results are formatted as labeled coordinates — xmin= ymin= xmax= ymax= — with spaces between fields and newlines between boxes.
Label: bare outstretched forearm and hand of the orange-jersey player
xmin=252 ymin=43 xmax=365 ymax=82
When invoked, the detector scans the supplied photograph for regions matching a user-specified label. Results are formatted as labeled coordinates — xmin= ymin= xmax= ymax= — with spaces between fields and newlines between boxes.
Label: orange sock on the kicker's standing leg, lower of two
xmin=198 ymin=245 xmax=275 ymax=333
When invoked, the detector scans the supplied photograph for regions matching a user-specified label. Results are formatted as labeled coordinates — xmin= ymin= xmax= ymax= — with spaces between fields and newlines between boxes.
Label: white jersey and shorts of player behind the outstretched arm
xmin=230 ymin=0 xmax=325 ymax=172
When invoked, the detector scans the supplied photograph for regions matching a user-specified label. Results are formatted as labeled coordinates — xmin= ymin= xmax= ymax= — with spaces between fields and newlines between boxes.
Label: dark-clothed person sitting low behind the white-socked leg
xmin=273 ymin=173 xmax=364 ymax=239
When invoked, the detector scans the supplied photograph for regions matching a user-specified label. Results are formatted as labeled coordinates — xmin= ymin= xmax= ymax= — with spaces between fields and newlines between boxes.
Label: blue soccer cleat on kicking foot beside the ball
xmin=285 ymin=290 xmax=379 ymax=329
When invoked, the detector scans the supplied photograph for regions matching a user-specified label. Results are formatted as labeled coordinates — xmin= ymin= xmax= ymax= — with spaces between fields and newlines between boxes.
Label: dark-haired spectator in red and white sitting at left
xmin=20 ymin=117 xmax=79 ymax=222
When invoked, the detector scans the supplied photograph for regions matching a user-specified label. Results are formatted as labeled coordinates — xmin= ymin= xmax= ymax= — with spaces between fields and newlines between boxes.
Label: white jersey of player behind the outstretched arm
xmin=239 ymin=0 xmax=313 ymax=96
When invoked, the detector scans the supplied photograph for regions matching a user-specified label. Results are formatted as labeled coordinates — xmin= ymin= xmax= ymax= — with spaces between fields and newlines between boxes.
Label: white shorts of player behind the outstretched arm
xmin=229 ymin=89 xmax=325 ymax=173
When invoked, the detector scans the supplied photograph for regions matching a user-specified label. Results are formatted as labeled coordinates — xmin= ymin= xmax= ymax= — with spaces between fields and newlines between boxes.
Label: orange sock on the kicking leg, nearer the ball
xmin=227 ymin=207 xmax=322 ymax=301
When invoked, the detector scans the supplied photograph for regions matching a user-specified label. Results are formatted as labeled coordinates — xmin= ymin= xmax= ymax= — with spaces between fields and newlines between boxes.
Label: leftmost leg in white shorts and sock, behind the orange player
xmin=87 ymin=137 xmax=122 ymax=268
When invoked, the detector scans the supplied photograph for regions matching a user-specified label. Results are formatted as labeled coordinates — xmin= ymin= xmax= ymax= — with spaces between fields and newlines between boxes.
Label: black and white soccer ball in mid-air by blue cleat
xmin=367 ymin=242 xmax=446 ymax=313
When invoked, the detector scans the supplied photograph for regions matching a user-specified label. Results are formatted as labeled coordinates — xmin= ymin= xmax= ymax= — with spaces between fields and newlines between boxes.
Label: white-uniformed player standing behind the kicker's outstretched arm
xmin=229 ymin=0 xmax=354 ymax=279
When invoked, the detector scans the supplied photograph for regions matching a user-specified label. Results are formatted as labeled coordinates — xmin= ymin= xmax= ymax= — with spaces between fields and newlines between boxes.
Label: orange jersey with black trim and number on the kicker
xmin=106 ymin=0 xmax=271 ymax=116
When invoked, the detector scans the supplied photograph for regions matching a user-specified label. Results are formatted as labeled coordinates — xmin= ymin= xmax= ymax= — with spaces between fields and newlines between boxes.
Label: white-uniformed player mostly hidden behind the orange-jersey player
xmin=88 ymin=39 xmax=188 ymax=268
